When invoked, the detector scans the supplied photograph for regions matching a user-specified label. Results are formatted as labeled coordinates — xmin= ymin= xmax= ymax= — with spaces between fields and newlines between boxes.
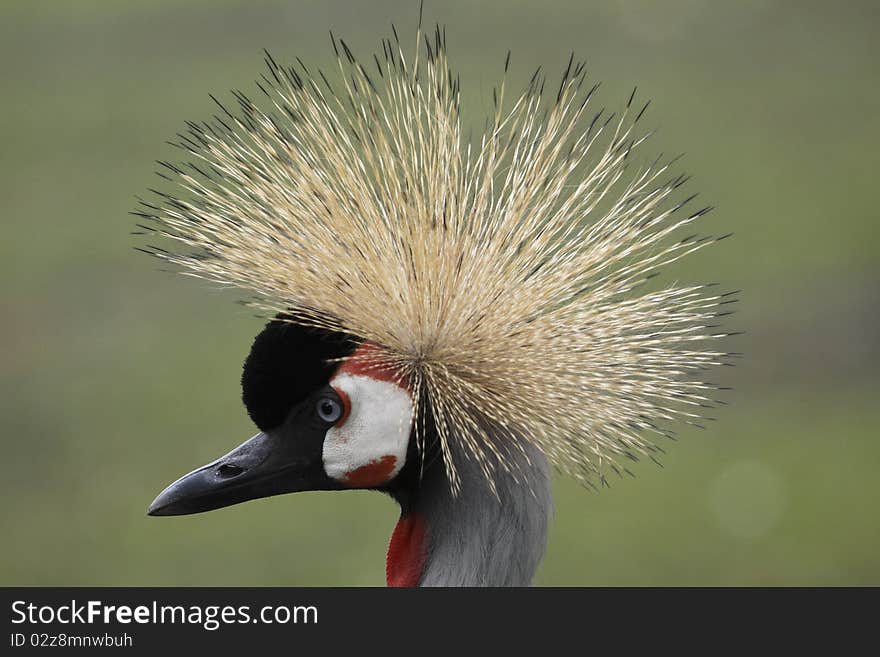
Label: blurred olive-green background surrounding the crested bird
xmin=0 ymin=0 xmax=880 ymax=585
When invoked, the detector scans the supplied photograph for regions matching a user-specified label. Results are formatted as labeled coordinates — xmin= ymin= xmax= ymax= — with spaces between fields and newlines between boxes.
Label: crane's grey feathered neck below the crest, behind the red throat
xmin=412 ymin=440 xmax=553 ymax=586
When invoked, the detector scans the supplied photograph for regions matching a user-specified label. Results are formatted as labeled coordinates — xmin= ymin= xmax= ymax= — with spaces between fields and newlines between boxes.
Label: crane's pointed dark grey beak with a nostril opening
xmin=147 ymin=432 xmax=335 ymax=516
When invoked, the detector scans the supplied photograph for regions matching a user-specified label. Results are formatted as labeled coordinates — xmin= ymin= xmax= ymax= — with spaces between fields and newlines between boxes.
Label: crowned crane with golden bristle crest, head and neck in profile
xmin=143 ymin=24 xmax=732 ymax=586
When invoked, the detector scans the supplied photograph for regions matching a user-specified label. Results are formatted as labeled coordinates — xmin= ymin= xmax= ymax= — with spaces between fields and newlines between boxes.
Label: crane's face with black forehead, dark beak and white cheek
xmin=149 ymin=322 xmax=413 ymax=515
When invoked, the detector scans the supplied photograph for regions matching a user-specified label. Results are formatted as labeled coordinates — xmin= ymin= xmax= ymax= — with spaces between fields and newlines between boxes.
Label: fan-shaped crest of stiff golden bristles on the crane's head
xmin=137 ymin=21 xmax=732 ymax=489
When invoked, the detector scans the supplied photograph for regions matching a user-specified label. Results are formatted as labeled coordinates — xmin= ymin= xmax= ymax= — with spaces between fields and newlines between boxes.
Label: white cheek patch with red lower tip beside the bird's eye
xmin=323 ymin=374 xmax=413 ymax=488
